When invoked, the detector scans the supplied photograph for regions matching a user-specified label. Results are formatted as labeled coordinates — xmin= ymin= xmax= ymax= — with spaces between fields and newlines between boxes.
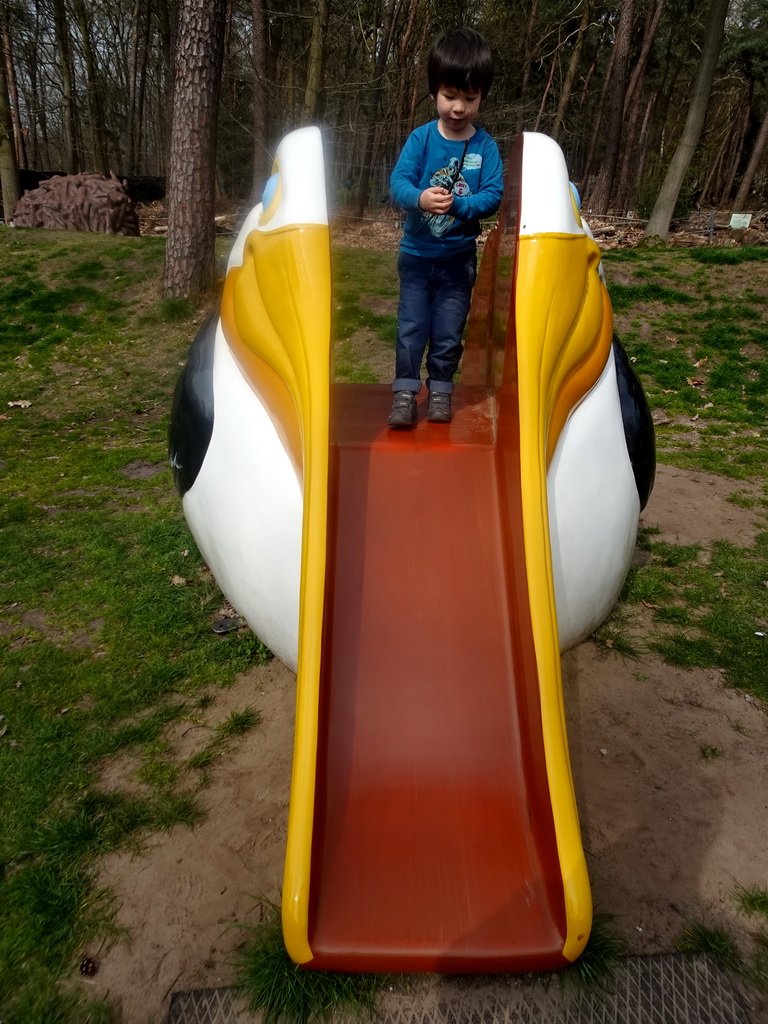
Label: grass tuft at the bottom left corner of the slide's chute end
xmin=237 ymin=904 xmax=386 ymax=1024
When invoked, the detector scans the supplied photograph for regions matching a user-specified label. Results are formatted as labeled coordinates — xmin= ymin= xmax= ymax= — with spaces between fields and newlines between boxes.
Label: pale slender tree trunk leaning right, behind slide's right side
xmin=643 ymin=0 xmax=728 ymax=241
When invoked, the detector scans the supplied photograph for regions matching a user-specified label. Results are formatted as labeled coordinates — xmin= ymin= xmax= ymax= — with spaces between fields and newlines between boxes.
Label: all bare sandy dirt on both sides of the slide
xmin=89 ymin=466 xmax=768 ymax=1024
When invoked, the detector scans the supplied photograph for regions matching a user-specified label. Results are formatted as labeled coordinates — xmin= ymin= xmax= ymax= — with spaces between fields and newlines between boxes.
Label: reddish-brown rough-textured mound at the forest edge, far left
xmin=13 ymin=173 xmax=138 ymax=234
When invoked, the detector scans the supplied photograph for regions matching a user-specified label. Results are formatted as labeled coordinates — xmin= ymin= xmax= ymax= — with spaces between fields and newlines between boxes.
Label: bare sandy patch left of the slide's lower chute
xmin=88 ymin=660 xmax=295 ymax=1024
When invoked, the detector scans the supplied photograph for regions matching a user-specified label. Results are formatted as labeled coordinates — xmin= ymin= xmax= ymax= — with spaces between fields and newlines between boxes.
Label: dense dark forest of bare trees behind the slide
xmin=0 ymin=0 xmax=768 ymax=231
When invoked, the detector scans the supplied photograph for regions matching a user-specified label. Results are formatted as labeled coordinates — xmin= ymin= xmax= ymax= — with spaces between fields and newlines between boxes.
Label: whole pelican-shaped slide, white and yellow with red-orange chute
xmin=170 ymin=128 xmax=654 ymax=972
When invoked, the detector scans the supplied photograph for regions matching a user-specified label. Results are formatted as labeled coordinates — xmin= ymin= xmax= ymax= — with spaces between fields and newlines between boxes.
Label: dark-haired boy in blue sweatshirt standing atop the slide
xmin=389 ymin=29 xmax=504 ymax=430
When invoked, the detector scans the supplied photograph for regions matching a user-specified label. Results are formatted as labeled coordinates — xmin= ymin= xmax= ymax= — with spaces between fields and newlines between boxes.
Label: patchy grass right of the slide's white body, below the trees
xmin=604 ymin=241 xmax=768 ymax=468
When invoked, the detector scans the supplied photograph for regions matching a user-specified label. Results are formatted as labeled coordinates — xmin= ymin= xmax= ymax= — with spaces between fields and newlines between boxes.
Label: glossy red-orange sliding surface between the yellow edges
xmin=308 ymin=385 xmax=566 ymax=972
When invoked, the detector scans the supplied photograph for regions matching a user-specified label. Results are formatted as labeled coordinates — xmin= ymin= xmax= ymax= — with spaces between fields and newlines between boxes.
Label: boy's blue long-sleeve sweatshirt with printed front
xmin=390 ymin=121 xmax=504 ymax=257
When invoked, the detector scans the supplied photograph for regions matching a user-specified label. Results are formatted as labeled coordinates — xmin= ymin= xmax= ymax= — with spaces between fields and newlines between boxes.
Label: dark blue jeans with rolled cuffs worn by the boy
xmin=392 ymin=246 xmax=477 ymax=394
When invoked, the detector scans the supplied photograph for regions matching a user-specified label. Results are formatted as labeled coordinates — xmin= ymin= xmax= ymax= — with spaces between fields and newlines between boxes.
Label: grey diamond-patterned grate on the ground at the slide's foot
xmin=163 ymin=953 xmax=750 ymax=1024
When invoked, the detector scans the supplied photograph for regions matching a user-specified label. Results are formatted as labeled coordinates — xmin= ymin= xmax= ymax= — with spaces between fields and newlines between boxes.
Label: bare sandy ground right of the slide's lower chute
xmin=563 ymin=643 xmax=768 ymax=952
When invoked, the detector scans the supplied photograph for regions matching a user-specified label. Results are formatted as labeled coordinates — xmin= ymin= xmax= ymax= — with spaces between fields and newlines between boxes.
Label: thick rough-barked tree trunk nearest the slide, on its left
xmin=165 ymin=0 xmax=226 ymax=298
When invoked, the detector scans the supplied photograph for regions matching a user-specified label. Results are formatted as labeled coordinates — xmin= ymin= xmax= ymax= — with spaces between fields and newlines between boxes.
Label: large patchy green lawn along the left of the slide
xmin=0 ymin=228 xmax=269 ymax=1024
